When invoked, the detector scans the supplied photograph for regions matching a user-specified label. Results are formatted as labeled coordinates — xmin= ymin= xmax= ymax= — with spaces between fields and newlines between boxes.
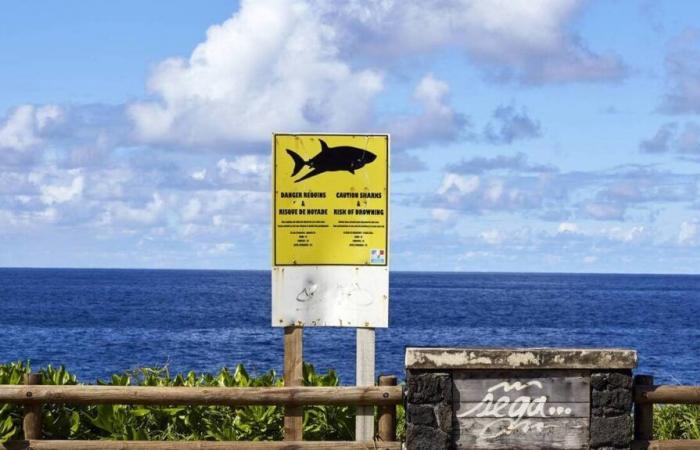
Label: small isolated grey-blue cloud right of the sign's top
xmin=484 ymin=106 xmax=542 ymax=144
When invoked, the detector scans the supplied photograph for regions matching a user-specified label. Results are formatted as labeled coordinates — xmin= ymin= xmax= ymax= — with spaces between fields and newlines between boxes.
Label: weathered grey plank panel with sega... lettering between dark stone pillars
xmin=452 ymin=370 xmax=591 ymax=450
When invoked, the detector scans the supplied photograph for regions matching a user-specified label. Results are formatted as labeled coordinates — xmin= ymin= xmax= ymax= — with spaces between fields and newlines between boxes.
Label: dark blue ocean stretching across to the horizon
xmin=0 ymin=269 xmax=700 ymax=384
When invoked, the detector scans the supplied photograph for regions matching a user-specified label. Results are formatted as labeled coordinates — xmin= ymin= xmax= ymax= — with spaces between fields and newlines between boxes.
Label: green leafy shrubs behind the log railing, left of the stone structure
xmin=0 ymin=362 xmax=402 ymax=441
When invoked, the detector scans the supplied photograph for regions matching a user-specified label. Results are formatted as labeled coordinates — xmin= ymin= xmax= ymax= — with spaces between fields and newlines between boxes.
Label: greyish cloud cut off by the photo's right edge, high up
xmin=659 ymin=28 xmax=700 ymax=114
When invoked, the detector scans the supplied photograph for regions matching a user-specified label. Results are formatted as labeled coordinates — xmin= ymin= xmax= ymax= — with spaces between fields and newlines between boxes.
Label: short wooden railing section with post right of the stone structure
xmin=632 ymin=375 xmax=700 ymax=450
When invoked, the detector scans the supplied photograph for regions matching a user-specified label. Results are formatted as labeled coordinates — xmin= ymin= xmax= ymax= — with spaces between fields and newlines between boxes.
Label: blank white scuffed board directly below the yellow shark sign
xmin=272 ymin=266 xmax=389 ymax=328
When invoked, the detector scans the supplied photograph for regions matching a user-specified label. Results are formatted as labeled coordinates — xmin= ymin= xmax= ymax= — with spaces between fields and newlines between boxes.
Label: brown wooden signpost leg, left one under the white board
xmin=284 ymin=327 xmax=304 ymax=441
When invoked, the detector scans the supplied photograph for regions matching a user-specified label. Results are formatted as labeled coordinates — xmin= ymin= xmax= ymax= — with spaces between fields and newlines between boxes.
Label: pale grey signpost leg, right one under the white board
xmin=355 ymin=328 xmax=375 ymax=441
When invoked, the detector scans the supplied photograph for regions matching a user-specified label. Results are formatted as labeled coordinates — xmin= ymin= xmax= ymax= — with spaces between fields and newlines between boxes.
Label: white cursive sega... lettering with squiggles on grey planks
xmin=457 ymin=380 xmax=572 ymax=440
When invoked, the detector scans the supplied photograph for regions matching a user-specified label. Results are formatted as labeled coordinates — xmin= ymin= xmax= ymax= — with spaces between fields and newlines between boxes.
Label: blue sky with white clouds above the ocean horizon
xmin=0 ymin=0 xmax=700 ymax=273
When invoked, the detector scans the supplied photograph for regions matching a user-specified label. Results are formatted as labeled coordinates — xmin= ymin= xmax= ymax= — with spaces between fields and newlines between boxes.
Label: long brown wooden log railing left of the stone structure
xmin=0 ymin=374 xmax=403 ymax=450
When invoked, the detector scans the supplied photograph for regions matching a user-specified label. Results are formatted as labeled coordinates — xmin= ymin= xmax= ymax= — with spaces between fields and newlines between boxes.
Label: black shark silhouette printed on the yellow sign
xmin=287 ymin=139 xmax=377 ymax=183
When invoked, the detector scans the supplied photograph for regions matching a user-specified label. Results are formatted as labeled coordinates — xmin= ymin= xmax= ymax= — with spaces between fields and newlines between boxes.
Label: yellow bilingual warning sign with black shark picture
xmin=272 ymin=134 xmax=389 ymax=266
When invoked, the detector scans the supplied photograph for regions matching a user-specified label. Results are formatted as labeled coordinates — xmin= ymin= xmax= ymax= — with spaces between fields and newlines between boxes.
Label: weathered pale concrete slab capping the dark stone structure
xmin=406 ymin=347 xmax=637 ymax=370
